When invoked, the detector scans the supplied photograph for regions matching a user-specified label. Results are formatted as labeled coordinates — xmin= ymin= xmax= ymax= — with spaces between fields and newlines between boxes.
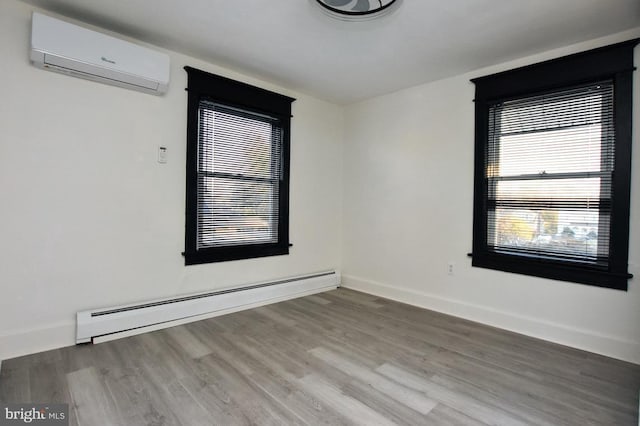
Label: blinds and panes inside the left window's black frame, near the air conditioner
xmin=197 ymin=100 xmax=283 ymax=249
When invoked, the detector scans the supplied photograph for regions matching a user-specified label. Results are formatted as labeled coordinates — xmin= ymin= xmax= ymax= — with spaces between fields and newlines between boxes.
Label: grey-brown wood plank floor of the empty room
xmin=0 ymin=289 xmax=640 ymax=426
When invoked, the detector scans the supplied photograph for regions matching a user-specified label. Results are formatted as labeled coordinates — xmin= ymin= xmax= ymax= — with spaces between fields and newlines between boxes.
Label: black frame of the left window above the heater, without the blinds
xmin=184 ymin=66 xmax=295 ymax=265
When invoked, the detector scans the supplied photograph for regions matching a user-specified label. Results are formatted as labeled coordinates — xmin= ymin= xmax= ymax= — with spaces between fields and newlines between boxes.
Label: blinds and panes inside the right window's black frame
xmin=486 ymin=81 xmax=615 ymax=267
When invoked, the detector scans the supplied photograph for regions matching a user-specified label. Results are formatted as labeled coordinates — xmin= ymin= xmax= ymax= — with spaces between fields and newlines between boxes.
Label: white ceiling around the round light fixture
xmin=18 ymin=0 xmax=640 ymax=104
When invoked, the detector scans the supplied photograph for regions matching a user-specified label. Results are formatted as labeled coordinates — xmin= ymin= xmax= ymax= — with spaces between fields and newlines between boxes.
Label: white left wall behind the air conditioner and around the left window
xmin=0 ymin=0 xmax=343 ymax=360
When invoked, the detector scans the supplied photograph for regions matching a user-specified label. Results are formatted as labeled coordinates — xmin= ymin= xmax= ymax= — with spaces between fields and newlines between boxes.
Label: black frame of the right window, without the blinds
xmin=471 ymin=39 xmax=640 ymax=291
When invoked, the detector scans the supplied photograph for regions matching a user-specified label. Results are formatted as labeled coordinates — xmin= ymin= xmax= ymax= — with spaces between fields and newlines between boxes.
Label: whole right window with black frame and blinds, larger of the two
xmin=472 ymin=40 xmax=638 ymax=290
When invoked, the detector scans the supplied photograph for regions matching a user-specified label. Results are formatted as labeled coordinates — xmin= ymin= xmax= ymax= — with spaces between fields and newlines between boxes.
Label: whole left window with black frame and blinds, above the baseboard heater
xmin=184 ymin=67 xmax=294 ymax=265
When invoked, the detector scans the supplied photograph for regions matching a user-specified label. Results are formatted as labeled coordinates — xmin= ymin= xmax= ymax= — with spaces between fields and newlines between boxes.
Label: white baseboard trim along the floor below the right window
xmin=342 ymin=275 xmax=640 ymax=364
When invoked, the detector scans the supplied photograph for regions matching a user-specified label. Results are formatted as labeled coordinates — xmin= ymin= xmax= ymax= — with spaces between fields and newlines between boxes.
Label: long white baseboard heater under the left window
xmin=76 ymin=271 xmax=340 ymax=343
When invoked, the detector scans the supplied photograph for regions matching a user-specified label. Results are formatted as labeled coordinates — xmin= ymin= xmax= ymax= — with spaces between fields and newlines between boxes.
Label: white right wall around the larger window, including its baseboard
xmin=342 ymin=28 xmax=640 ymax=363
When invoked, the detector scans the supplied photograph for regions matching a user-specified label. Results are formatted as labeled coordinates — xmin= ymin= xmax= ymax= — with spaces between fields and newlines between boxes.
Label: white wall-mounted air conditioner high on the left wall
xmin=30 ymin=12 xmax=170 ymax=95
